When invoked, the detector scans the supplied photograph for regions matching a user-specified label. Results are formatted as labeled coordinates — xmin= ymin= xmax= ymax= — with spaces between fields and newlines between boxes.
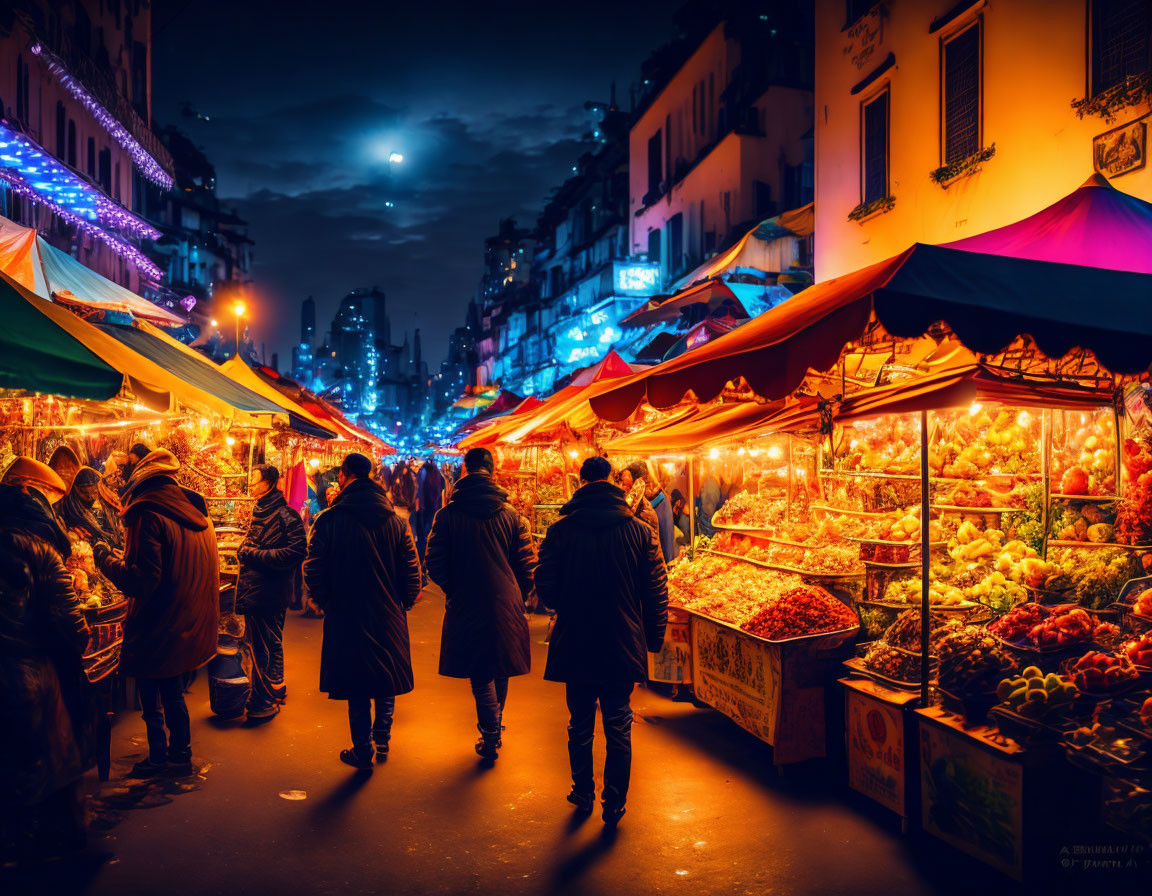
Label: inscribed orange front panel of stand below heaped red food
xmin=692 ymin=617 xmax=780 ymax=744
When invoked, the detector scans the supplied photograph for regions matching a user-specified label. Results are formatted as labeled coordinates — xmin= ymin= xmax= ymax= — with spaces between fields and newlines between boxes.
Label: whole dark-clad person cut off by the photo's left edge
xmin=0 ymin=474 xmax=89 ymax=863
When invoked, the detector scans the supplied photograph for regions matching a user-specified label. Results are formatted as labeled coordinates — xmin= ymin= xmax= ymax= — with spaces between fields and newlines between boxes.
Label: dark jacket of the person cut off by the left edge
xmin=0 ymin=485 xmax=89 ymax=806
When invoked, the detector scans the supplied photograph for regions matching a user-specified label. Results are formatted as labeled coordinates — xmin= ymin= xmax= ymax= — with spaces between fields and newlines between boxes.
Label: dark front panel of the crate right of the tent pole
xmin=920 ymin=719 xmax=1024 ymax=880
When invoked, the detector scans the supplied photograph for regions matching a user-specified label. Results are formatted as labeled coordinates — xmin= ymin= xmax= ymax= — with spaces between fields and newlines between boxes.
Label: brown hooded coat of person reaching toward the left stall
xmin=93 ymin=472 xmax=220 ymax=678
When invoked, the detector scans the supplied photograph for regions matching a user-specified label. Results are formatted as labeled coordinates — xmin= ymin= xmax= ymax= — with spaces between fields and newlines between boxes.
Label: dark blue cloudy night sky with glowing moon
xmin=152 ymin=0 xmax=675 ymax=371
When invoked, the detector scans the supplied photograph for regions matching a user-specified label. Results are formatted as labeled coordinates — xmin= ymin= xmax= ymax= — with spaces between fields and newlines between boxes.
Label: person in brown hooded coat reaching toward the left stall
xmin=92 ymin=448 xmax=220 ymax=777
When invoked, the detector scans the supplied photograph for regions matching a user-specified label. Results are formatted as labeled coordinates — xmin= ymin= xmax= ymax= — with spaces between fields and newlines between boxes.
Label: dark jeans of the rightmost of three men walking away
xmin=566 ymin=682 xmax=632 ymax=807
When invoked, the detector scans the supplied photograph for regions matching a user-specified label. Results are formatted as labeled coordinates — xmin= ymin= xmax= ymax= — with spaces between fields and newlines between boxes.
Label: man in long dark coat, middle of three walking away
xmin=426 ymin=448 xmax=536 ymax=760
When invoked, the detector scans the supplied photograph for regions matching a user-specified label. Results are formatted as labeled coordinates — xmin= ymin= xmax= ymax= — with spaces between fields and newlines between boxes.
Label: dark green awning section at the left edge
xmin=0 ymin=274 xmax=124 ymax=401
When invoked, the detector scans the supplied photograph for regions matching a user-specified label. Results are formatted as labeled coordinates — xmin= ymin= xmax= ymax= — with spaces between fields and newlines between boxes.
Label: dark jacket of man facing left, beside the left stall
xmin=236 ymin=488 xmax=308 ymax=613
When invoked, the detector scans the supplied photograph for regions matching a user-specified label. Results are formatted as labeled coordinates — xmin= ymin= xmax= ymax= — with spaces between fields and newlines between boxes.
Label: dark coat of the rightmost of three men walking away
xmin=536 ymin=481 xmax=668 ymax=684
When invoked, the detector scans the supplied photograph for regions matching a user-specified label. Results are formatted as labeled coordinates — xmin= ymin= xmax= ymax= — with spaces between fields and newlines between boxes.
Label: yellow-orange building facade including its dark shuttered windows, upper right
xmin=816 ymin=0 xmax=1152 ymax=280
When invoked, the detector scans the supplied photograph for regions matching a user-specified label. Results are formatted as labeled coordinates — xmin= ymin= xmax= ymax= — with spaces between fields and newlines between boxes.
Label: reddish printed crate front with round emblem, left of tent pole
xmin=844 ymin=689 xmax=905 ymax=815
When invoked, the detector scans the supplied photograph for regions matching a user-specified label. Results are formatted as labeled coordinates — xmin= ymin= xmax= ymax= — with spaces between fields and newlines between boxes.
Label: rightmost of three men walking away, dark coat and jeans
xmin=536 ymin=457 xmax=668 ymax=825
